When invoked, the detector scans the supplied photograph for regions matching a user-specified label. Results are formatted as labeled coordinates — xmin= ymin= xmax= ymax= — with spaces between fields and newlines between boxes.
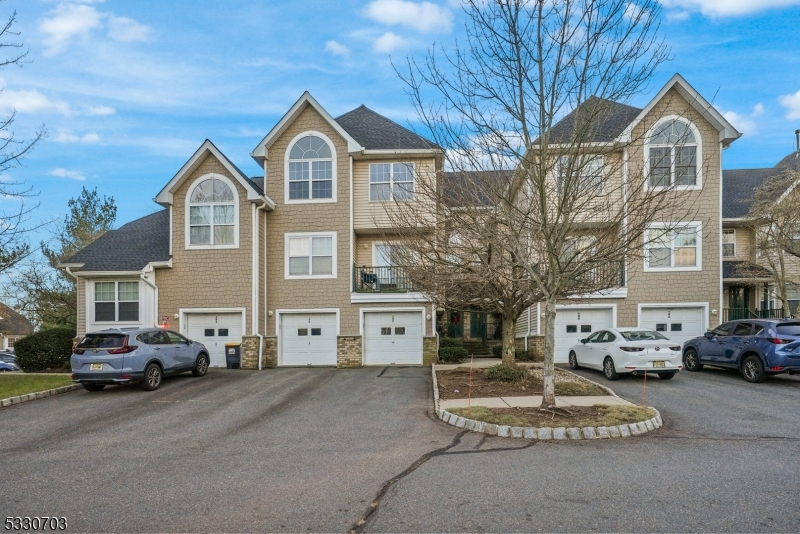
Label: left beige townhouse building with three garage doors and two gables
xmin=62 ymin=93 xmax=442 ymax=368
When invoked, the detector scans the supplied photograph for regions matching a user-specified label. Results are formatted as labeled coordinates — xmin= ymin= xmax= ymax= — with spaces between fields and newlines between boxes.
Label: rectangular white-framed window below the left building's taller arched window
xmin=285 ymin=232 xmax=336 ymax=279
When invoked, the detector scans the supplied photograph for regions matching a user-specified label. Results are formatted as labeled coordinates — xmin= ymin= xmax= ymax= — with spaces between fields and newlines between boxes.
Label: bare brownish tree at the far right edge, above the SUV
xmin=738 ymin=169 xmax=800 ymax=315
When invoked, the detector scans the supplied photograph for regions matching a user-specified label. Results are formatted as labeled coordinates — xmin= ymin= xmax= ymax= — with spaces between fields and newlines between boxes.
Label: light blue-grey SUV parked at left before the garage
xmin=71 ymin=328 xmax=209 ymax=391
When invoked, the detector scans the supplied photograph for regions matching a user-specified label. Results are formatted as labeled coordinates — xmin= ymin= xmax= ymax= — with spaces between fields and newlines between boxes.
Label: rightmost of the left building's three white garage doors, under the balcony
xmin=364 ymin=312 xmax=423 ymax=365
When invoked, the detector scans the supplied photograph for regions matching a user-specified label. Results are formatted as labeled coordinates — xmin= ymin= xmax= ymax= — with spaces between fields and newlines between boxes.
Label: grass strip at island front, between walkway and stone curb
xmin=448 ymin=404 xmax=656 ymax=428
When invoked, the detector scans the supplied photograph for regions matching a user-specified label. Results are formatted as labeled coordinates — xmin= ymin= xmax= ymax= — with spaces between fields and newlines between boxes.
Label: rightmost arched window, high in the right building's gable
xmin=644 ymin=116 xmax=702 ymax=189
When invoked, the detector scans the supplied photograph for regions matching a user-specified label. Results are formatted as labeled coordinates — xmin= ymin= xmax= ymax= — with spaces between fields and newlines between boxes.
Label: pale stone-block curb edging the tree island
xmin=431 ymin=365 xmax=663 ymax=441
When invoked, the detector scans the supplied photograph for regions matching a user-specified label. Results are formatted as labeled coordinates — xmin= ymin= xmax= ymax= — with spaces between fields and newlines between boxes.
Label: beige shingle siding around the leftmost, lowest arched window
xmin=156 ymin=155 xmax=253 ymax=333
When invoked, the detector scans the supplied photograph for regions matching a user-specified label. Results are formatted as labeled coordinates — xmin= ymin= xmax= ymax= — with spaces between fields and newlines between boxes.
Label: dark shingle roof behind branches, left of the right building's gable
xmin=533 ymin=96 xmax=642 ymax=145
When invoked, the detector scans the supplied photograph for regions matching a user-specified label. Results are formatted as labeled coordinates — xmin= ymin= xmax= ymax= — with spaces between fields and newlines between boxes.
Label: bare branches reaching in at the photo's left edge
xmin=0 ymin=6 xmax=46 ymax=273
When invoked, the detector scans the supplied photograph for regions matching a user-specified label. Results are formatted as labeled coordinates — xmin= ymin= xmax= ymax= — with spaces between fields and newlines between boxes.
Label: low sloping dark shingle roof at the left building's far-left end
xmin=64 ymin=210 xmax=170 ymax=271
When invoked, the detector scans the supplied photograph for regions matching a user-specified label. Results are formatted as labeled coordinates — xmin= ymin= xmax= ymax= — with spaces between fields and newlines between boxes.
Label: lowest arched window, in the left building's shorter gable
xmin=189 ymin=178 xmax=236 ymax=246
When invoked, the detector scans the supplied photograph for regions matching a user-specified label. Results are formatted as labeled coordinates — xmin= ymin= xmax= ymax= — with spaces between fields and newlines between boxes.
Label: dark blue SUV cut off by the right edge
xmin=683 ymin=319 xmax=800 ymax=382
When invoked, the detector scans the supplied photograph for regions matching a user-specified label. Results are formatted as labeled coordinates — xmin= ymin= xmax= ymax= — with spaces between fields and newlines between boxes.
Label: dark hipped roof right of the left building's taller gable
xmin=336 ymin=104 xmax=439 ymax=150
